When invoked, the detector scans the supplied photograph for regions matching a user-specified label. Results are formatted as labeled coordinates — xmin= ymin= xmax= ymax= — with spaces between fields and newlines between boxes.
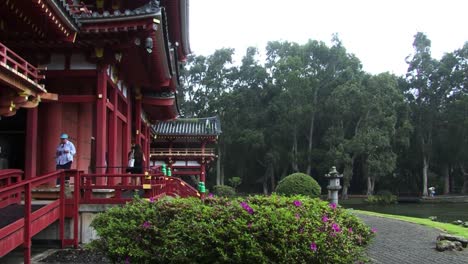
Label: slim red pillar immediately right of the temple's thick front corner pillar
xmin=108 ymin=79 xmax=118 ymax=178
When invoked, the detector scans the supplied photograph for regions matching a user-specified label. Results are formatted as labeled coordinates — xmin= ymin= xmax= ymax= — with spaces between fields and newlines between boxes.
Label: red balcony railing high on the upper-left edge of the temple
xmin=0 ymin=43 xmax=44 ymax=83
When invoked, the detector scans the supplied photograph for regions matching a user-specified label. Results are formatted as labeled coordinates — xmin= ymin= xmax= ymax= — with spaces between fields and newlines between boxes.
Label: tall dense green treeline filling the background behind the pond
xmin=179 ymin=33 xmax=468 ymax=195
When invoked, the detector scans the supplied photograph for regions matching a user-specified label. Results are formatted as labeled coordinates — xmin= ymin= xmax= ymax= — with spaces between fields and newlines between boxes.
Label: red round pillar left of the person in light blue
xmin=24 ymin=107 xmax=38 ymax=179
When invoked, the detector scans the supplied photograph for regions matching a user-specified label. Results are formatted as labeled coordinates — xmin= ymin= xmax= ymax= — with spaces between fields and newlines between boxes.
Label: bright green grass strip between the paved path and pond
xmin=353 ymin=210 xmax=468 ymax=238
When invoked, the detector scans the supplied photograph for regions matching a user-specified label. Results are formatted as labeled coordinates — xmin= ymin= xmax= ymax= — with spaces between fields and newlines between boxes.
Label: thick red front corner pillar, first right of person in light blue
xmin=96 ymin=65 xmax=107 ymax=184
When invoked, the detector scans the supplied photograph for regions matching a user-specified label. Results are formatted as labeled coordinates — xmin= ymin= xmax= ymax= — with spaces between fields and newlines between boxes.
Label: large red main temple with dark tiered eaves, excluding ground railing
xmin=0 ymin=0 xmax=190 ymax=178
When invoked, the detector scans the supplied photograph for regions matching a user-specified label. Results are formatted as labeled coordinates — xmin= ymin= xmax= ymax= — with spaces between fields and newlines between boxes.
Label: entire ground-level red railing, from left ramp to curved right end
xmin=0 ymin=167 xmax=201 ymax=263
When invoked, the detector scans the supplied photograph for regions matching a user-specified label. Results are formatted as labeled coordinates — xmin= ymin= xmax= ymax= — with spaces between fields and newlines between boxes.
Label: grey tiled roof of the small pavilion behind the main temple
xmin=153 ymin=116 xmax=222 ymax=136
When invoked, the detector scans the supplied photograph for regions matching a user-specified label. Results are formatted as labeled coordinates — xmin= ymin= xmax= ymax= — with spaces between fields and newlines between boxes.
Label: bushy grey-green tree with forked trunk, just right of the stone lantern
xmin=326 ymin=73 xmax=404 ymax=197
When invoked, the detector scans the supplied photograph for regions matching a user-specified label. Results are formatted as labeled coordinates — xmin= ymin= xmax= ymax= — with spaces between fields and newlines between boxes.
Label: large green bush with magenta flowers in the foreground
xmin=92 ymin=195 xmax=373 ymax=263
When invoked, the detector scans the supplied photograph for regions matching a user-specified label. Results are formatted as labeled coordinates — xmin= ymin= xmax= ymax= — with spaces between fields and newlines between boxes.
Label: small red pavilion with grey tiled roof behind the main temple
xmin=150 ymin=117 xmax=221 ymax=189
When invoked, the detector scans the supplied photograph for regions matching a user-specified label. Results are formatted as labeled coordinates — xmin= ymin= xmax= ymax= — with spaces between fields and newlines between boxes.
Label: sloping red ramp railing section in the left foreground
xmin=0 ymin=170 xmax=80 ymax=263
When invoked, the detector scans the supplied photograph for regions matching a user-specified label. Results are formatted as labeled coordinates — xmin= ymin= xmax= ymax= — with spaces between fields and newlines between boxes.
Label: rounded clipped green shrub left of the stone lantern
xmin=276 ymin=173 xmax=322 ymax=197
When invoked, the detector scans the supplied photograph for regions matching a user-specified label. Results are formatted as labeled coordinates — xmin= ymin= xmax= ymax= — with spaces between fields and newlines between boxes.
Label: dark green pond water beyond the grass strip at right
xmin=343 ymin=203 xmax=468 ymax=222
